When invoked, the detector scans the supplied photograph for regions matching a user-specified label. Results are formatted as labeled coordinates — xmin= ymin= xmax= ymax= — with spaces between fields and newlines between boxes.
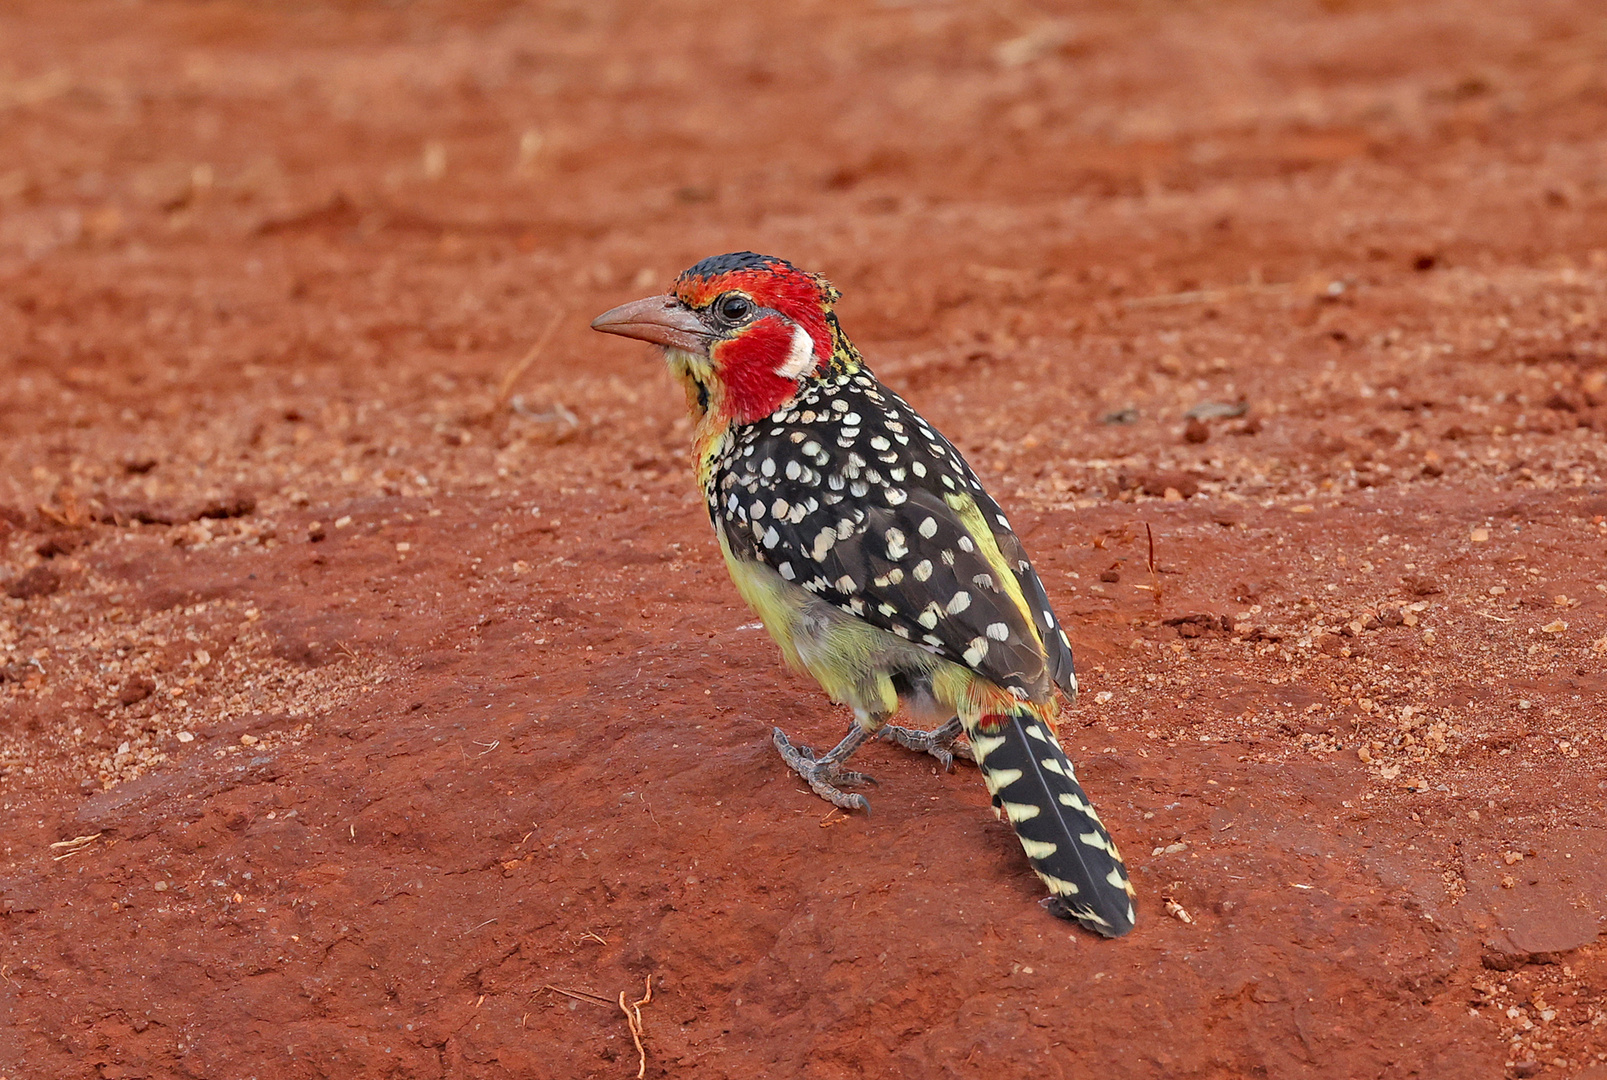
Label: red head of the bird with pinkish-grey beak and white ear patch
xmin=591 ymin=251 xmax=852 ymax=424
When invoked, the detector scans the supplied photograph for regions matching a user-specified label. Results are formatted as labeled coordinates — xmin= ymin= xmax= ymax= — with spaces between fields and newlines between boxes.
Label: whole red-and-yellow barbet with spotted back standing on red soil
xmin=591 ymin=251 xmax=1135 ymax=937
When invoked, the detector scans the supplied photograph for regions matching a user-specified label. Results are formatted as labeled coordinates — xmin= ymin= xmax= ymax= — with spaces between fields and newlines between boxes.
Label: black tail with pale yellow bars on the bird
xmin=966 ymin=704 xmax=1133 ymax=937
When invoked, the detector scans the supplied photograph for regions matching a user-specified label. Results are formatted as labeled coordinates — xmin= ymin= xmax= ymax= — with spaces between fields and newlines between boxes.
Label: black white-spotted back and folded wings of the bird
xmin=707 ymin=368 xmax=1075 ymax=701
